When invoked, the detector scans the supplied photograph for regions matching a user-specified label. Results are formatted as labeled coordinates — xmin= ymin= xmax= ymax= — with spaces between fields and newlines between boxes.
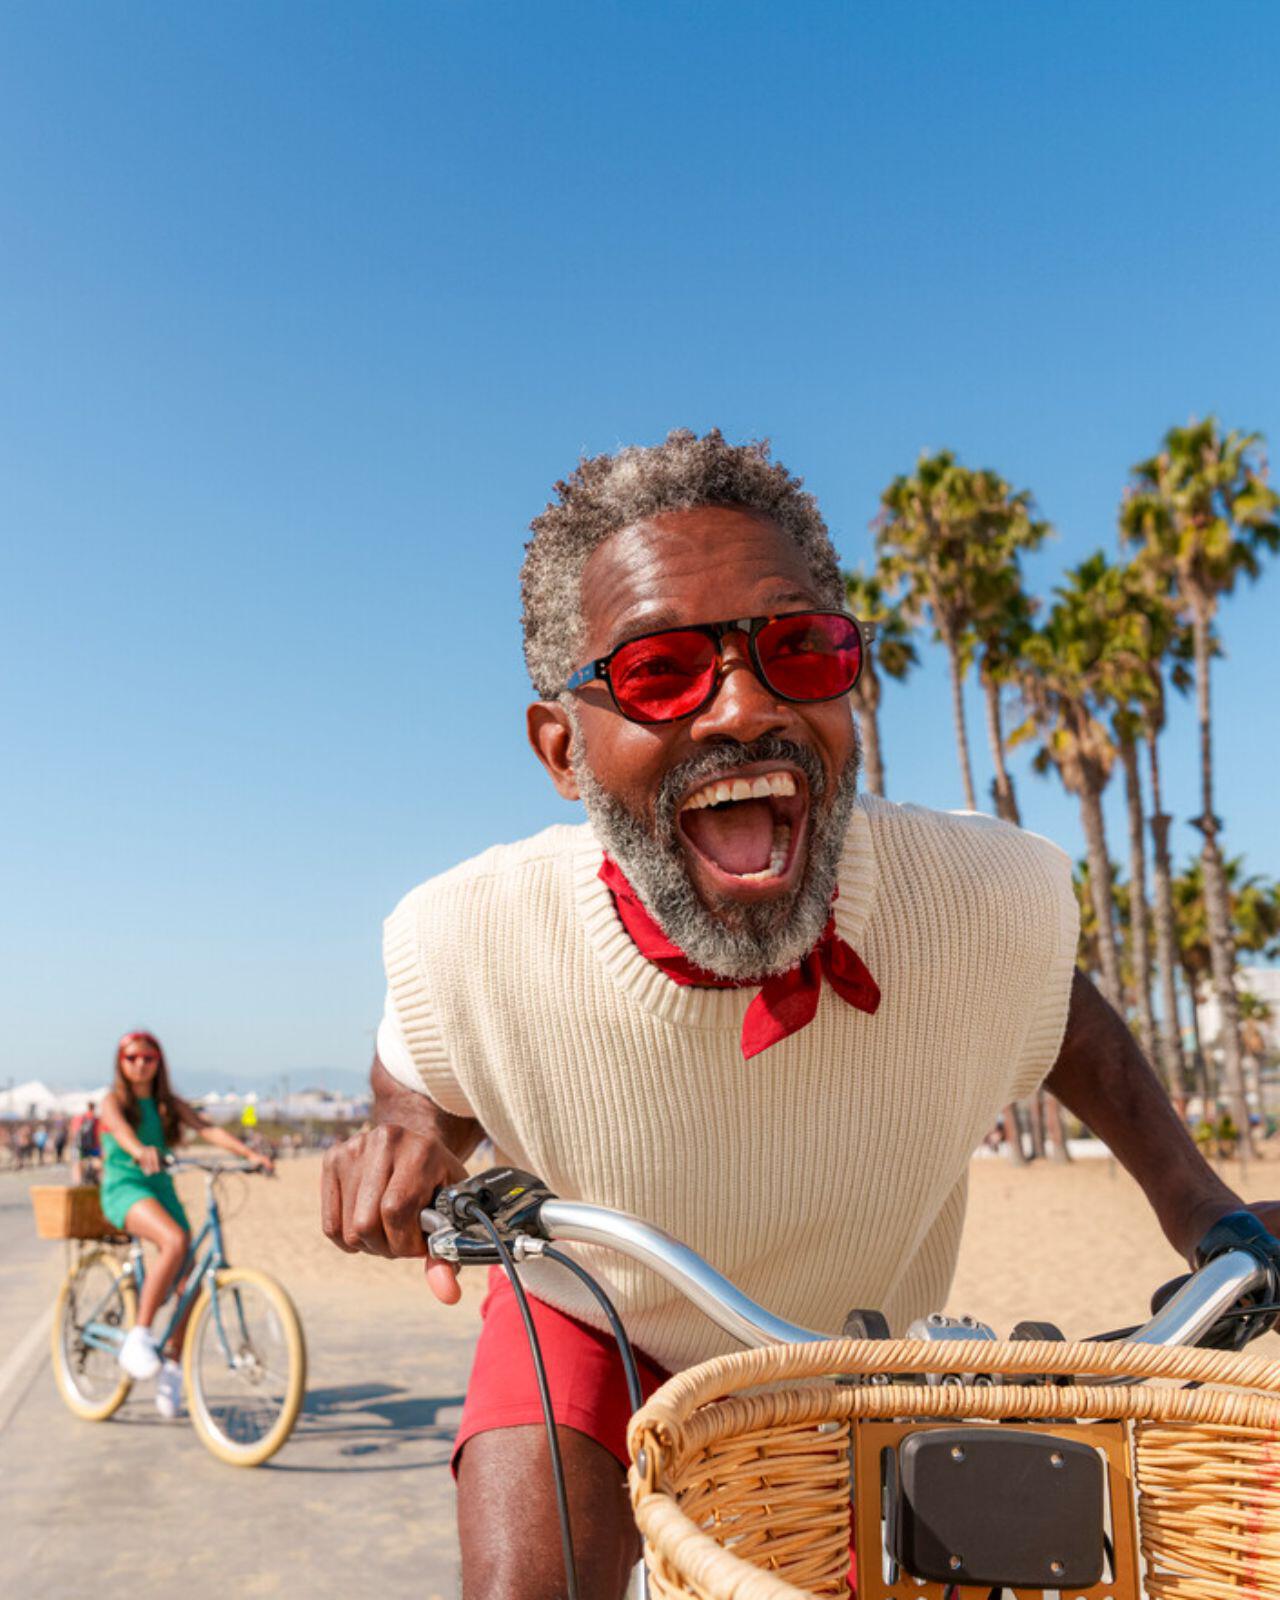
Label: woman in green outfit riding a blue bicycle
xmin=99 ymin=1034 xmax=272 ymax=1418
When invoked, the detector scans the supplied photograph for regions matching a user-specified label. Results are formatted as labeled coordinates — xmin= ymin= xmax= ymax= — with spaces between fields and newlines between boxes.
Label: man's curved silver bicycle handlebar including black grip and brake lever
xmin=419 ymin=1168 xmax=1277 ymax=1347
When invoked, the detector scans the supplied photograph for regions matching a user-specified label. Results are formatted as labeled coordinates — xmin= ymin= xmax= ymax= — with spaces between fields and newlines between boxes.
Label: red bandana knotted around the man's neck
xmin=600 ymin=856 xmax=880 ymax=1061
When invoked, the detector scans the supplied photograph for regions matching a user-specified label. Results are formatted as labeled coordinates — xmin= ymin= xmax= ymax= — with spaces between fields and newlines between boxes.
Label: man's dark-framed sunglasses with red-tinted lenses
xmin=565 ymin=611 xmax=875 ymax=722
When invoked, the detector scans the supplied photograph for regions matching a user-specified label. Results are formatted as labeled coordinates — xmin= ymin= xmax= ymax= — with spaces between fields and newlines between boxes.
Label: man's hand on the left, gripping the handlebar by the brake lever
xmin=320 ymin=1061 xmax=480 ymax=1306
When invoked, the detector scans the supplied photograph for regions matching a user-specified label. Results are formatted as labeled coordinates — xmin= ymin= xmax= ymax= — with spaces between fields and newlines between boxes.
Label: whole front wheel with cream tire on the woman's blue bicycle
xmin=182 ymin=1267 xmax=307 ymax=1467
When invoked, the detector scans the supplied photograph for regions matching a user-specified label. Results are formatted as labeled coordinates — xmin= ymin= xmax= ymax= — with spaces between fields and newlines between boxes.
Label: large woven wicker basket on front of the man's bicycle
xmin=627 ymin=1339 xmax=1280 ymax=1600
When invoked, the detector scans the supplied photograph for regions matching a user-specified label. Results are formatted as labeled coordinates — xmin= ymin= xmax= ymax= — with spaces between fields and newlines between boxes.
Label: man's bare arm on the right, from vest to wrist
xmin=1045 ymin=973 xmax=1248 ymax=1259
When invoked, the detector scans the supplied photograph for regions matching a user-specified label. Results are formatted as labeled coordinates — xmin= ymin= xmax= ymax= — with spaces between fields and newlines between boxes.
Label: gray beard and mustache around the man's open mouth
xmin=570 ymin=726 xmax=859 ymax=979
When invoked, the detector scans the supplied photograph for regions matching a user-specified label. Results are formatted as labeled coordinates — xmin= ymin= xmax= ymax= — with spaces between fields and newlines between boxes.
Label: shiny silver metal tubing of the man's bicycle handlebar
xmin=421 ymin=1198 xmax=1267 ymax=1347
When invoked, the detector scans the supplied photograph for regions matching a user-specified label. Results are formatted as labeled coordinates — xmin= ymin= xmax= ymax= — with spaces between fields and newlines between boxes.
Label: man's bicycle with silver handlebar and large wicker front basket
xmin=421 ymin=1168 xmax=1280 ymax=1600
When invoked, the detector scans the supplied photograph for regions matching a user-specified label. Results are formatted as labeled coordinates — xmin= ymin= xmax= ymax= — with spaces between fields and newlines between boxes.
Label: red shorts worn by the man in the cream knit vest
xmin=451 ymin=1267 xmax=670 ymax=1475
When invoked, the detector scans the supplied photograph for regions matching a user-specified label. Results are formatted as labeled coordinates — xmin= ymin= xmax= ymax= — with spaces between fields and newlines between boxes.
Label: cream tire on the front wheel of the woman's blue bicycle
xmin=182 ymin=1267 xmax=307 ymax=1467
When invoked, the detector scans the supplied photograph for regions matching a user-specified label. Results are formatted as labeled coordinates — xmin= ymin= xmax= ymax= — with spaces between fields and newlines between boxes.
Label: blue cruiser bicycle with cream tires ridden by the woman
xmin=53 ymin=1157 xmax=307 ymax=1467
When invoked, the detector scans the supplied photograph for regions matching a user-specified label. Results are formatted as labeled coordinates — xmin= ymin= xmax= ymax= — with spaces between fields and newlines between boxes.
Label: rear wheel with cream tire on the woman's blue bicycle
xmin=51 ymin=1250 xmax=138 ymax=1422
